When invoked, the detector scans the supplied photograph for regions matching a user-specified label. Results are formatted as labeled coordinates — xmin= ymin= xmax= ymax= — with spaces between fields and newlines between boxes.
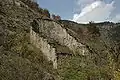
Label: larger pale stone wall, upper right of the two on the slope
xmin=32 ymin=19 xmax=87 ymax=55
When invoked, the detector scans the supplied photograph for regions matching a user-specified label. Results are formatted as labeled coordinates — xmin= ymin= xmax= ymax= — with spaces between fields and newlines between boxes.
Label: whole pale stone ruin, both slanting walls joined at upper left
xmin=30 ymin=19 xmax=88 ymax=68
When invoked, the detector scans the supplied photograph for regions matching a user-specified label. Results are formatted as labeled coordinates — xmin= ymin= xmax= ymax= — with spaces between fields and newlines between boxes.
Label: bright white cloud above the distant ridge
xmin=72 ymin=0 xmax=120 ymax=23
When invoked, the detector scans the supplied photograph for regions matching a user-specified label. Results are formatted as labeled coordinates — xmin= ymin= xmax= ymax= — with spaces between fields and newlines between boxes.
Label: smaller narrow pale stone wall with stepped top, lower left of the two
xmin=30 ymin=26 xmax=57 ymax=69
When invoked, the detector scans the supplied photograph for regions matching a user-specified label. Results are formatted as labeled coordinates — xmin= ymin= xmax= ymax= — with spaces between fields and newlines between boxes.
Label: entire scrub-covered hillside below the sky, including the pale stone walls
xmin=0 ymin=0 xmax=120 ymax=80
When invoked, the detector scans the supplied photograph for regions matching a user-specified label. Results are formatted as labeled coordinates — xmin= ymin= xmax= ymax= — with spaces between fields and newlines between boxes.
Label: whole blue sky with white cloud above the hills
xmin=37 ymin=0 xmax=120 ymax=23
